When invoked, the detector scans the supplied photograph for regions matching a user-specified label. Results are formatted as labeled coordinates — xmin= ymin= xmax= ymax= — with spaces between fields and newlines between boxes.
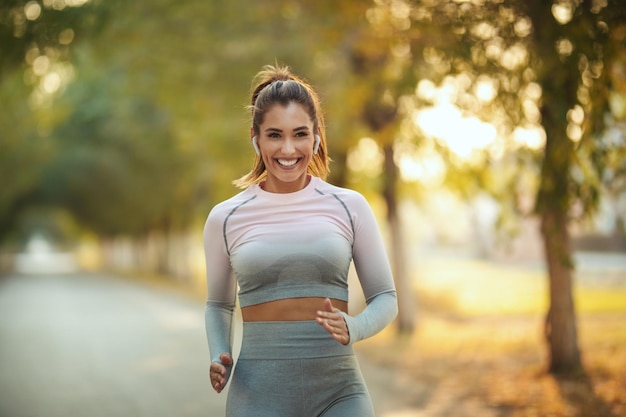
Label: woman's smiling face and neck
xmin=257 ymin=102 xmax=316 ymax=193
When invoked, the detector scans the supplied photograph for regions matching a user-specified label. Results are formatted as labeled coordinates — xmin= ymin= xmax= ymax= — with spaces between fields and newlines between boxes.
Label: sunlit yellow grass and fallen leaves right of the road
xmin=357 ymin=257 xmax=626 ymax=417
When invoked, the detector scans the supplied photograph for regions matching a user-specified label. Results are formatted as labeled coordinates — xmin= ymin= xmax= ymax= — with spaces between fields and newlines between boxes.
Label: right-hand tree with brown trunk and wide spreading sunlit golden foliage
xmin=356 ymin=0 xmax=624 ymax=372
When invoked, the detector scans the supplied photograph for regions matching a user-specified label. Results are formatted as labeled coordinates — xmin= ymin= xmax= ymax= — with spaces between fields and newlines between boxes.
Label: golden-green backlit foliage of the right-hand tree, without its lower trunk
xmin=360 ymin=0 xmax=626 ymax=226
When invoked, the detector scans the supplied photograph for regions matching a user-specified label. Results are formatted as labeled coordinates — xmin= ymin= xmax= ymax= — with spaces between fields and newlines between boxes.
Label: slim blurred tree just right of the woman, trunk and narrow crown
xmin=338 ymin=2 xmax=416 ymax=334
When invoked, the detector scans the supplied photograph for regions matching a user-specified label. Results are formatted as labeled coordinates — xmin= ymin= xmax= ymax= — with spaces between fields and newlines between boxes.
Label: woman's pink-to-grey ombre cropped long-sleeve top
xmin=204 ymin=177 xmax=397 ymax=361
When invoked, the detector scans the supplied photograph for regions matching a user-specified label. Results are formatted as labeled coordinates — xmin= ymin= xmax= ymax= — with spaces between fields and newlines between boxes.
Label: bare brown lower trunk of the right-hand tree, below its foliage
xmin=541 ymin=211 xmax=581 ymax=373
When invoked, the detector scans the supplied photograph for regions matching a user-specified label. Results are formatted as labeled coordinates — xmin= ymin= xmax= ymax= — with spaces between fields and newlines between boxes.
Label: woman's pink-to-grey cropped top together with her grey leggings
xmin=204 ymin=177 xmax=397 ymax=417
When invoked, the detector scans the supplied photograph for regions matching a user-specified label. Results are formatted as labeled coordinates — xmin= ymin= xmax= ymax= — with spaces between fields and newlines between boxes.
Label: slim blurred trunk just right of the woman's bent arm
xmin=383 ymin=143 xmax=415 ymax=334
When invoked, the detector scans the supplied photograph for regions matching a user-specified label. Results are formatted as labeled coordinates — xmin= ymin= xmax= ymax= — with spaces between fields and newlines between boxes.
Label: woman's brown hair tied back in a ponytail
xmin=233 ymin=65 xmax=331 ymax=188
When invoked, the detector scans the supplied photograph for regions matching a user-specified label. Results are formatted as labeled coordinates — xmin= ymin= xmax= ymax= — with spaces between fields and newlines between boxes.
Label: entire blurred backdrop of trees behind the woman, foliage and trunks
xmin=0 ymin=0 xmax=626 ymax=371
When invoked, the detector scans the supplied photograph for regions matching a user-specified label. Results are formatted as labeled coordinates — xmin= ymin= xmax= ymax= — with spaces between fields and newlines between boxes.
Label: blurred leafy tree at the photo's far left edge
xmin=0 ymin=0 xmax=107 ymax=243
